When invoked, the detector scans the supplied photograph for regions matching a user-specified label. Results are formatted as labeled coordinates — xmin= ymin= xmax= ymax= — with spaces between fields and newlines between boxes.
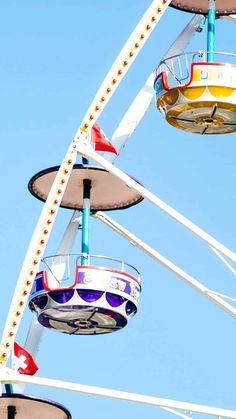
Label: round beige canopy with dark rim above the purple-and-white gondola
xmin=28 ymin=164 xmax=143 ymax=211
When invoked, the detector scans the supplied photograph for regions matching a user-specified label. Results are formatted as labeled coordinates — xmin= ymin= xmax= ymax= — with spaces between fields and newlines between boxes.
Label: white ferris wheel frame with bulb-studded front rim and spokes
xmin=0 ymin=0 xmax=236 ymax=419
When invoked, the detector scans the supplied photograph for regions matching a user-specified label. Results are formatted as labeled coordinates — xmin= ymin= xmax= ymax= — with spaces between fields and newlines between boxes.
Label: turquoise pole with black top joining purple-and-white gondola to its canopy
xmin=81 ymin=179 xmax=91 ymax=265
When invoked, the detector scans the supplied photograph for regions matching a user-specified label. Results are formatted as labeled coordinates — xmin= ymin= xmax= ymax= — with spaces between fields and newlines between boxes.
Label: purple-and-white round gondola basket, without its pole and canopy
xmin=29 ymin=255 xmax=141 ymax=335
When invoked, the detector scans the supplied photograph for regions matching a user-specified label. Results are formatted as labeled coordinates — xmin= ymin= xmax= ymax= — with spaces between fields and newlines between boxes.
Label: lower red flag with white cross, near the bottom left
xmin=14 ymin=342 xmax=39 ymax=375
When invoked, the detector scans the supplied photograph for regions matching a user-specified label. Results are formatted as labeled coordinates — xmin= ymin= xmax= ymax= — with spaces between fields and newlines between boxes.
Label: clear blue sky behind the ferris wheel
xmin=0 ymin=0 xmax=236 ymax=419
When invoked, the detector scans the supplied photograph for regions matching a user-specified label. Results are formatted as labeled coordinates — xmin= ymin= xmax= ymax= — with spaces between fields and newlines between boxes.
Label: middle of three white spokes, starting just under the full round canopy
xmin=93 ymin=211 xmax=236 ymax=318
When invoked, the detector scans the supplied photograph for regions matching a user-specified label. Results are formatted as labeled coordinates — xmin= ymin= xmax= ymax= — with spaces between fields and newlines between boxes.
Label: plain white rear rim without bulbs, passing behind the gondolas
xmin=17 ymin=10 xmax=205 ymax=374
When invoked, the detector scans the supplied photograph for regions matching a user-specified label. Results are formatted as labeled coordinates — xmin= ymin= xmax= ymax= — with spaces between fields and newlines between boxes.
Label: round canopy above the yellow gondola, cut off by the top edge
xmin=170 ymin=0 xmax=236 ymax=16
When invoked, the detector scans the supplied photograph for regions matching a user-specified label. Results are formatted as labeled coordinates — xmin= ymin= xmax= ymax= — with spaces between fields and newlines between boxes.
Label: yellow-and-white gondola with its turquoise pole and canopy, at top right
xmin=154 ymin=0 xmax=236 ymax=134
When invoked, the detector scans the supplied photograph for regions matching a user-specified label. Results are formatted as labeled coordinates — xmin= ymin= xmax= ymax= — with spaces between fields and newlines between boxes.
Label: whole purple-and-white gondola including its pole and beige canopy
xmin=29 ymin=164 xmax=143 ymax=335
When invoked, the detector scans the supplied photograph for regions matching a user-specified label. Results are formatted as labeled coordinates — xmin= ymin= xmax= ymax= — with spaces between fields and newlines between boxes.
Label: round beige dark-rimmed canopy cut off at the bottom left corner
xmin=0 ymin=394 xmax=71 ymax=419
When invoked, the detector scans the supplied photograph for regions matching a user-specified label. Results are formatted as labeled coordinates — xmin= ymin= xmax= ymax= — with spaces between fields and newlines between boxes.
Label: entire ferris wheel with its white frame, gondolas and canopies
xmin=0 ymin=0 xmax=236 ymax=419
